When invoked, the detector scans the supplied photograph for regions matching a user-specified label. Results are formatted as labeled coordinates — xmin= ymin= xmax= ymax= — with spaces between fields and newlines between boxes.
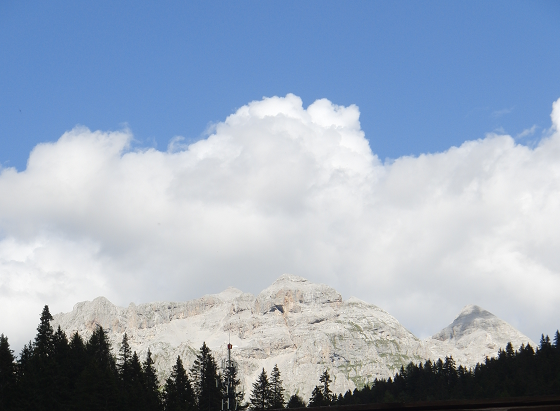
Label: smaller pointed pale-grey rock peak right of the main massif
xmin=425 ymin=305 xmax=535 ymax=367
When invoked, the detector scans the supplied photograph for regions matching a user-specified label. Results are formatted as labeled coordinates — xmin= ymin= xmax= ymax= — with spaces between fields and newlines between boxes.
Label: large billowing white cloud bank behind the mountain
xmin=0 ymin=94 xmax=560 ymax=352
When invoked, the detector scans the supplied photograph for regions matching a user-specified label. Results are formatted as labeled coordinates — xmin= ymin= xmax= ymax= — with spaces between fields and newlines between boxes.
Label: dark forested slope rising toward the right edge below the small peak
xmin=333 ymin=331 xmax=560 ymax=405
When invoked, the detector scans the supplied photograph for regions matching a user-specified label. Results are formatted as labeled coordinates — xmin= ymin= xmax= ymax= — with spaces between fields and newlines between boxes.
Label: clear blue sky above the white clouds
xmin=0 ymin=1 xmax=560 ymax=170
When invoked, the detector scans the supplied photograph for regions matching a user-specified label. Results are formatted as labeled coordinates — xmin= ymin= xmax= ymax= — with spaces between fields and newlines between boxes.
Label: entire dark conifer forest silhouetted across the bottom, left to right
xmin=0 ymin=306 xmax=560 ymax=411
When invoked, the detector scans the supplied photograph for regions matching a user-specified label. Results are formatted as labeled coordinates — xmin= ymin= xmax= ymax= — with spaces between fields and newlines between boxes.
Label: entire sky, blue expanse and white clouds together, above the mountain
xmin=0 ymin=1 xmax=560 ymax=349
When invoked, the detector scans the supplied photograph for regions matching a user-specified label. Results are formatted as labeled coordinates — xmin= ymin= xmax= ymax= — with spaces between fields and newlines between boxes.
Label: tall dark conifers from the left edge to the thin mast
xmin=0 ymin=306 xmax=238 ymax=411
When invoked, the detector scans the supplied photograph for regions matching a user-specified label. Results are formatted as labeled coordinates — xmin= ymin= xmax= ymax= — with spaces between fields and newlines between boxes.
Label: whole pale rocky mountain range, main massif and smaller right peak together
xmin=53 ymin=274 xmax=532 ymax=398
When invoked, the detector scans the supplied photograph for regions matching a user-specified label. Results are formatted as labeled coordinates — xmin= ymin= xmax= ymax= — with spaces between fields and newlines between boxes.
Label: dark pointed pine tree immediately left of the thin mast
xmin=191 ymin=342 xmax=222 ymax=411
